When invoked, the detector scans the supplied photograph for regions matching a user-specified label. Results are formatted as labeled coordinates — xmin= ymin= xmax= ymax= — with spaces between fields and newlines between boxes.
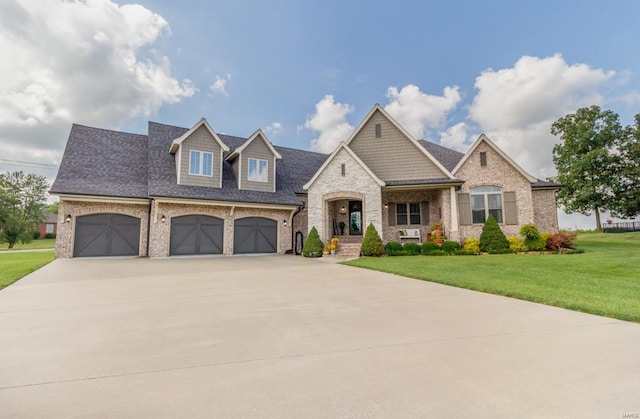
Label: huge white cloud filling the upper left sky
xmin=0 ymin=0 xmax=195 ymax=176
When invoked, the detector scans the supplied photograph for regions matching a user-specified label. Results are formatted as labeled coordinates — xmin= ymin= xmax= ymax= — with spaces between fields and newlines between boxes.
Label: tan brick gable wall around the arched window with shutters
xmin=456 ymin=142 xmax=536 ymax=240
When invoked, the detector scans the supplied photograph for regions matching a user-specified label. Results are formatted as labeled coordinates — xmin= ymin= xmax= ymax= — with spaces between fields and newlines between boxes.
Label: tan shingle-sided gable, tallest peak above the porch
xmin=348 ymin=105 xmax=451 ymax=181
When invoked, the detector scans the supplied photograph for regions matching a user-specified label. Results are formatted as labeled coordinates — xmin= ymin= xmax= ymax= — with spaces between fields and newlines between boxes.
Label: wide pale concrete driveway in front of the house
xmin=0 ymin=256 xmax=640 ymax=418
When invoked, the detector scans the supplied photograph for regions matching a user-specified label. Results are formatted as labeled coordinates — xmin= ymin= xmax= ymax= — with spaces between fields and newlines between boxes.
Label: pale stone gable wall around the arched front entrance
xmin=307 ymin=149 xmax=383 ymax=242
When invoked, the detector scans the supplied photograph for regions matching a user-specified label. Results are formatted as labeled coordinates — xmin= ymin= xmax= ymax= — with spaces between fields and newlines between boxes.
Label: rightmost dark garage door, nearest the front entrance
xmin=233 ymin=217 xmax=278 ymax=253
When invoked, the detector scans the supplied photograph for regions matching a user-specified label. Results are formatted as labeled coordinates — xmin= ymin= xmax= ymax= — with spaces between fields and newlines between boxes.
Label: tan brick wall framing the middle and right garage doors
xmin=149 ymin=201 xmax=293 ymax=257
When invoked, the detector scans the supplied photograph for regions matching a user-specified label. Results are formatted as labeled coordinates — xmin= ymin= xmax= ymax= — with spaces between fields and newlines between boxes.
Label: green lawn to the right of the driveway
xmin=345 ymin=232 xmax=640 ymax=322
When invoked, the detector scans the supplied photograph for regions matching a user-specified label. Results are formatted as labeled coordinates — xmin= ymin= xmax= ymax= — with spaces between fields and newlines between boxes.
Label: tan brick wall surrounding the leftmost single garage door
xmin=56 ymin=201 xmax=149 ymax=259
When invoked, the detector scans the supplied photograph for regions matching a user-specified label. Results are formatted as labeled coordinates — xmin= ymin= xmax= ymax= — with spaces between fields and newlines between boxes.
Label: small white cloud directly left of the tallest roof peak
xmin=304 ymin=95 xmax=353 ymax=153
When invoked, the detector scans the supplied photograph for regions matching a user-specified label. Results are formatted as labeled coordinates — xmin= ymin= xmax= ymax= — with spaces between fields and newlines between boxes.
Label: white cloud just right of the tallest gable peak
xmin=384 ymin=84 xmax=461 ymax=139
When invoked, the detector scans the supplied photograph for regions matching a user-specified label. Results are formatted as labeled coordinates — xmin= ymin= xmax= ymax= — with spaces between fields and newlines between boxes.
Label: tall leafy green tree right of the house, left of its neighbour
xmin=551 ymin=106 xmax=626 ymax=230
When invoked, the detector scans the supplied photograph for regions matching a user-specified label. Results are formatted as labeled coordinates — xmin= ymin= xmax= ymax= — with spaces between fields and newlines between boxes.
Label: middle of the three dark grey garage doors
xmin=170 ymin=215 xmax=224 ymax=255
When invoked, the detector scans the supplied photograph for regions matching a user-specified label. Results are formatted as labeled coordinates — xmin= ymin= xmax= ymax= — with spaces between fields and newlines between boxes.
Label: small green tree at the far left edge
xmin=0 ymin=172 xmax=49 ymax=249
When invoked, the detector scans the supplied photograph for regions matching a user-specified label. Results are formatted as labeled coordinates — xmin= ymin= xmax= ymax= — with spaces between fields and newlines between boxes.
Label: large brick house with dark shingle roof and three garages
xmin=51 ymin=105 xmax=559 ymax=258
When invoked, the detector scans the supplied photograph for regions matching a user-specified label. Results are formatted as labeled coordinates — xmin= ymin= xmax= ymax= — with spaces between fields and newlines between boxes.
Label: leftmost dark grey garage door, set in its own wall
xmin=73 ymin=214 xmax=140 ymax=257
